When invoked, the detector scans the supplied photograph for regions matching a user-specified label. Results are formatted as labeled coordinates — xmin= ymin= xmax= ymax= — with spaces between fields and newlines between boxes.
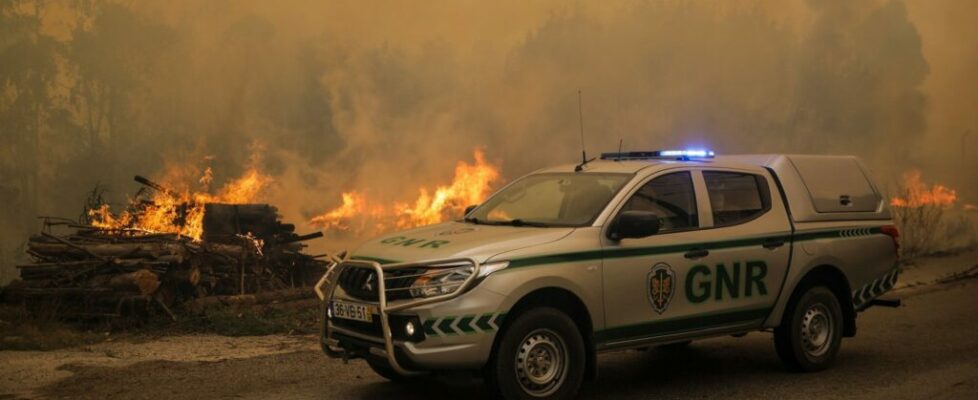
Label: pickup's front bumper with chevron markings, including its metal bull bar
xmin=316 ymin=258 xmax=505 ymax=375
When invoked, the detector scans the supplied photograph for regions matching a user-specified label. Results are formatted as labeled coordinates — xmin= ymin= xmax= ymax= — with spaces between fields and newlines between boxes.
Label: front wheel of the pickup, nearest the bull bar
xmin=485 ymin=308 xmax=587 ymax=399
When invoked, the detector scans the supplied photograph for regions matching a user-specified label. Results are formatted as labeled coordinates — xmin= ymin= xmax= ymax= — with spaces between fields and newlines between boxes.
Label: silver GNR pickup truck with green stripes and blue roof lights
xmin=316 ymin=150 xmax=899 ymax=399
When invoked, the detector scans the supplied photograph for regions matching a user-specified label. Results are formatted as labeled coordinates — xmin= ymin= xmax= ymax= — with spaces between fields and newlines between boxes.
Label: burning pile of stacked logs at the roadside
xmin=5 ymin=176 xmax=326 ymax=318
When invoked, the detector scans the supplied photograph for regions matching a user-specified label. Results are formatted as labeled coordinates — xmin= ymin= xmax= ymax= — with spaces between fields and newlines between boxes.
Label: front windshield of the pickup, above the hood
xmin=465 ymin=173 xmax=632 ymax=226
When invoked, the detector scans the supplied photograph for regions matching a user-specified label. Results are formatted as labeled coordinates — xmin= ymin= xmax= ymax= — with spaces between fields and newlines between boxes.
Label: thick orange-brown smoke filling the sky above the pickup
xmin=0 ymin=0 xmax=978 ymax=282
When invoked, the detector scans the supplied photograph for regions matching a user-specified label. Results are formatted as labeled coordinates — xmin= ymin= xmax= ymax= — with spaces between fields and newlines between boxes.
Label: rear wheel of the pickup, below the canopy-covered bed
xmin=774 ymin=286 xmax=844 ymax=372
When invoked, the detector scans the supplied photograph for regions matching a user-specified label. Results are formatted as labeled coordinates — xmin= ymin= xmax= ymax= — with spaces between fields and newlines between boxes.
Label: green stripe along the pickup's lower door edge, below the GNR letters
xmin=594 ymin=308 xmax=771 ymax=343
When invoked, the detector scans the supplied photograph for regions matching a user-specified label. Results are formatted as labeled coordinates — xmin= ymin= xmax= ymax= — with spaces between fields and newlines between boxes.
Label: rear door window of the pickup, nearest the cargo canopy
xmin=703 ymin=171 xmax=771 ymax=226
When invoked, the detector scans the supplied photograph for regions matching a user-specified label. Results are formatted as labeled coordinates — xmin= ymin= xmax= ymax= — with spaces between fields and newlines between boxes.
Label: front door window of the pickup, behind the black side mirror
xmin=622 ymin=171 xmax=699 ymax=233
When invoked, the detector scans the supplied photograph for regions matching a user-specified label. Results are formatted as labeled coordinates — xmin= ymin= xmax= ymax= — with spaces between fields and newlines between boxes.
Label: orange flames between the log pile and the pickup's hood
xmin=309 ymin=150 xmax=499 ymax=231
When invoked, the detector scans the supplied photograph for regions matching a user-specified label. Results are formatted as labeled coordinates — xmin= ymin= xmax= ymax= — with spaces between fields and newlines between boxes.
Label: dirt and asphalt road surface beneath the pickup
xmin=0 ymin=253 xmax=978 ymax=400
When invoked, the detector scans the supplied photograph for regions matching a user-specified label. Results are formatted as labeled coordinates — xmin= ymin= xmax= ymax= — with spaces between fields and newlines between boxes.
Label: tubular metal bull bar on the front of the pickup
xmin=314 ymin=257 xmax=481 ymax=375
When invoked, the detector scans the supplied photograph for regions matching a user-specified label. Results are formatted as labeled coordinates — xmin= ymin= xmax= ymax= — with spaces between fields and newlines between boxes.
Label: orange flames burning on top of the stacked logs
xmin=88 ymin=168 xmax=271 ymax=241
